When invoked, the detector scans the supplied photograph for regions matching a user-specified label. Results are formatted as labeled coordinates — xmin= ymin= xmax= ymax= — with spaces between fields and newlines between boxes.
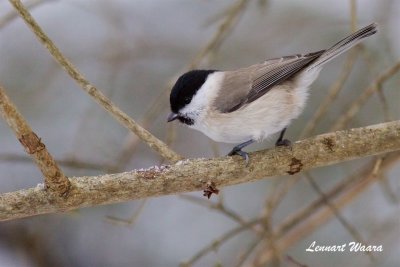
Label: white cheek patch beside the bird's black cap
xmin=179 ymin=71 xmax=224 ymax=119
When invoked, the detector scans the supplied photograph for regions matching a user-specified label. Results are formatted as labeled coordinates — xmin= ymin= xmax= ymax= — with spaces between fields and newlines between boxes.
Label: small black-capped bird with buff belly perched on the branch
xmin=168 ymin=23 xmax=377 ymax=163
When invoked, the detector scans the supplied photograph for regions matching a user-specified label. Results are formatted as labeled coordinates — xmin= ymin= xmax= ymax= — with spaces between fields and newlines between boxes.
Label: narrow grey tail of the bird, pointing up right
xmin=308 ymin=23 xmax=378 ymax=70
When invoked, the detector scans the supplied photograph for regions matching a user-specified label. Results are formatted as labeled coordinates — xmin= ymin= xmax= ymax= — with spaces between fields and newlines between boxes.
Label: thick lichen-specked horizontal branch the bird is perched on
xmin=0 ymin=121 xmax=400 ymax=220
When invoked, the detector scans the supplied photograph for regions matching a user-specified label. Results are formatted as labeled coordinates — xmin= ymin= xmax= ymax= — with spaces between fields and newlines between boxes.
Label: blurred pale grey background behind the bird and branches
xmin=0 ymin=0 xmax=400 ymax=267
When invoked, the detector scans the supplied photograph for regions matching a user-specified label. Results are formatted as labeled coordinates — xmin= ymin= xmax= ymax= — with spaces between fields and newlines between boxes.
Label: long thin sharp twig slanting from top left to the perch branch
xmin=9 ymin=0 xmax=182 ymax=161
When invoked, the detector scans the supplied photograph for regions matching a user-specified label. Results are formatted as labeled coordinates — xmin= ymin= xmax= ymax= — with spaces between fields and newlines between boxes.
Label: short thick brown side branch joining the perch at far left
xmin=0 ymin=85 xmax=70 ymax=195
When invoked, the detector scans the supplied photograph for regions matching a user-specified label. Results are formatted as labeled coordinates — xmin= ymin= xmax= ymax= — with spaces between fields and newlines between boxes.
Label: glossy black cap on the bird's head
xmin=169 ymin=70 xmax=216 ymax=113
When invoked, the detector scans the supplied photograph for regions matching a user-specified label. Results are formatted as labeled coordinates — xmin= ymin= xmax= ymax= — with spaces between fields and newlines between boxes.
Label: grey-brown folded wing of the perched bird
xmin=217 ymin=50 xmax=325 ymax=113
